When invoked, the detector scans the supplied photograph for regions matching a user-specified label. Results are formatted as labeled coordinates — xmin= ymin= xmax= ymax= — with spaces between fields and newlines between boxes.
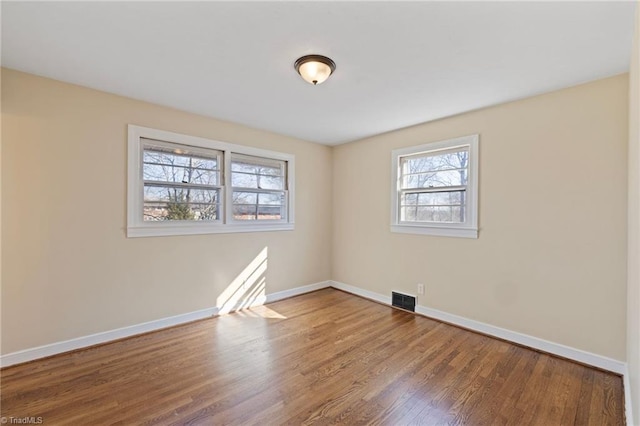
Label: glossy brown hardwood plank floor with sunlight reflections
xmin=1 ymin=289 xmax=624 ymax=425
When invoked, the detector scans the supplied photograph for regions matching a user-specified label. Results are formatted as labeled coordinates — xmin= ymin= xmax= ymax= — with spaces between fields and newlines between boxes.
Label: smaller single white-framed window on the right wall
xmin=391 ymin=135 xmax=478 ymax=238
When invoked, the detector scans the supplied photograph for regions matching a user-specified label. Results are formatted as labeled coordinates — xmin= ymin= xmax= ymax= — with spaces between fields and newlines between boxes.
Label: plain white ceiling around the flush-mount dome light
xmin=1 ymin=1 xmax=635 ymax=145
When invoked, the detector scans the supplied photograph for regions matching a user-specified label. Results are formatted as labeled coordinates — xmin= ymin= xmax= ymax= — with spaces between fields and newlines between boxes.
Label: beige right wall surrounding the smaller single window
xmin=332 ymin=74 xmax=628 ymax=360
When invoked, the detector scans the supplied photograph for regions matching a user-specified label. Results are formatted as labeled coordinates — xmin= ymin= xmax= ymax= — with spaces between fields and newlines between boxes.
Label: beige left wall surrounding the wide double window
xmin=2 ymin=69 xmax=332 ymax=354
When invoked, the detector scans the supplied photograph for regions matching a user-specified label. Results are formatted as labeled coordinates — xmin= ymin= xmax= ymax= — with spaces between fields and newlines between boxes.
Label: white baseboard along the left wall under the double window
xmin=0 ymin=281 xmax=330 ymax=367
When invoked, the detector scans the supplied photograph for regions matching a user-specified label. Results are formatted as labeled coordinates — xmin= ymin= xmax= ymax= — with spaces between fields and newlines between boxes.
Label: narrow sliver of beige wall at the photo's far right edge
xmin=627 ymin=2 xmax=640 ymax=425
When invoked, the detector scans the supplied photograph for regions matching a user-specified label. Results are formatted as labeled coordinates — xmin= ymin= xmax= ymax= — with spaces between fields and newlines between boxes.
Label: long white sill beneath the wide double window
xmin=127 ymin=223 xmax=294 ymax=238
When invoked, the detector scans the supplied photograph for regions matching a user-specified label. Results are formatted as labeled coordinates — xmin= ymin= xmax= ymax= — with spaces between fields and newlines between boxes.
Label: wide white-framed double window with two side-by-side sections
xmin=127 ymin=125 xmax=294 ymax=237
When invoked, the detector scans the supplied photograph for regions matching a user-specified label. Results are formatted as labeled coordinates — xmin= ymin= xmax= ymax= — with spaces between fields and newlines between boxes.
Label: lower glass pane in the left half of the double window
xmin=143 ymin=186 xmax=219 ymax=221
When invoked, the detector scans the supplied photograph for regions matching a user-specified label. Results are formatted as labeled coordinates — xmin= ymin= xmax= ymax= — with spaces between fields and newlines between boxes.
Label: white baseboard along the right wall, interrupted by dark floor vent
xmin=331 ymin=281 xmax=627 ymax=374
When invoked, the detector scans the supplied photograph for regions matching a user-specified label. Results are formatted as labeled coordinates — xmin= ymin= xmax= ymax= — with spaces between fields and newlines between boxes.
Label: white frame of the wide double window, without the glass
xmin=127 ymin=124 xmax=295 ymax=238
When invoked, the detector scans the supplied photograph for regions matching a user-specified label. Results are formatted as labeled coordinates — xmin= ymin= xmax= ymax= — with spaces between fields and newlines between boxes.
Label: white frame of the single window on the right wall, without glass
xmin=391 ymin=135 xmax=479 ymax=238
